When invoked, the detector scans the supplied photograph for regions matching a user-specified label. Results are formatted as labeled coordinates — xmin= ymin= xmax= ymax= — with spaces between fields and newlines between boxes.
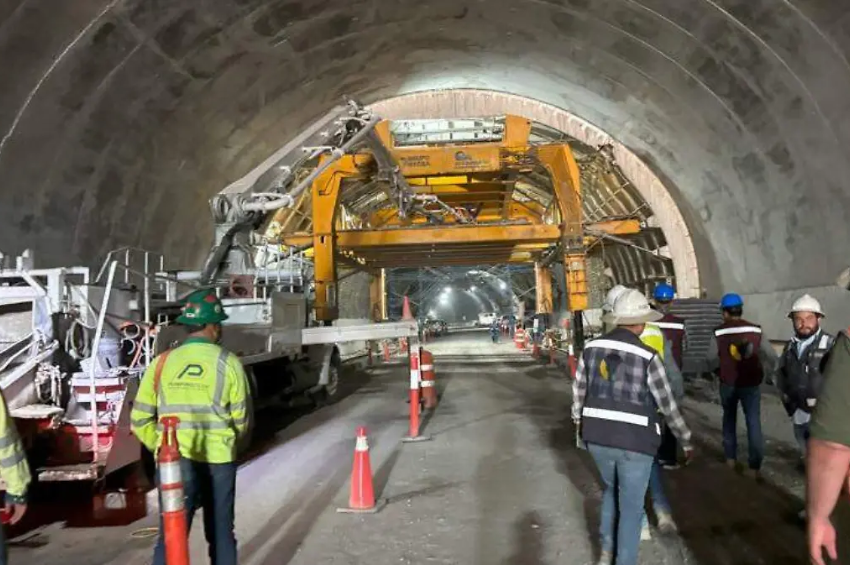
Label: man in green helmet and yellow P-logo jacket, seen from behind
xmin=130 ymin=290 xmax=249 ymax=565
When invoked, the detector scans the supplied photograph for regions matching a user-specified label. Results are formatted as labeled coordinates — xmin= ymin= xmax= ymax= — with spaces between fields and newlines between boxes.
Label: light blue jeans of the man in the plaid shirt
xmin=587 ymin=443 xmax=654 ymax=565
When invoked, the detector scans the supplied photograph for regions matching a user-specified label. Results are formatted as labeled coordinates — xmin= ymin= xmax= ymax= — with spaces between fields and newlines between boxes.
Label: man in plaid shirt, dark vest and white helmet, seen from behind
xmin=572 ymin=289 xmax=692 ymax=565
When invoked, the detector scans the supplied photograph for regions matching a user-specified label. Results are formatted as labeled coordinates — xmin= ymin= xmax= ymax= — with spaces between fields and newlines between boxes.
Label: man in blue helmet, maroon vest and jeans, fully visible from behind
xmin=707 ymin=294 xmax=777 ymax=481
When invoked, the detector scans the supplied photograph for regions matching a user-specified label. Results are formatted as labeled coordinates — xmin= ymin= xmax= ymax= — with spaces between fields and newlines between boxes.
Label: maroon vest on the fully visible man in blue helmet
xmin=714 ymin=320 xmax=764 ymax=387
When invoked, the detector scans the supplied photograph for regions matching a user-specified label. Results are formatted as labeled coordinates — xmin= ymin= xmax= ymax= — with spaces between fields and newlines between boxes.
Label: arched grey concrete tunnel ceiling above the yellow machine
xmin=0 ymin=0 xmax=850 ymax=300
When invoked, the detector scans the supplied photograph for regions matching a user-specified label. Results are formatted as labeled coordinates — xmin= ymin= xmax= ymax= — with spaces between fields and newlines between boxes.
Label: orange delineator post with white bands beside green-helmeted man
xmin=157 ymin=416 xmax=189 ymax=565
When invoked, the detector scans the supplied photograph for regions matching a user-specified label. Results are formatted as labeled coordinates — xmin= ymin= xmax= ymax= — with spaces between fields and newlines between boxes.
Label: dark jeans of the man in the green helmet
xmin=153 ymin=459 xmax=236 ymax=565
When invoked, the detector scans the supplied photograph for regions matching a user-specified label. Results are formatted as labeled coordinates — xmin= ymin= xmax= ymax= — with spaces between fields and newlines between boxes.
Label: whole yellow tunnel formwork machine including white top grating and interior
xmin=267 ymin=115 xmax=640 ymax=338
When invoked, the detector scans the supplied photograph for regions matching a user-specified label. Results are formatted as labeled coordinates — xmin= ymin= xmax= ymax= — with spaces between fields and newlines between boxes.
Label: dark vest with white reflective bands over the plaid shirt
xmin=581 ymin=328 xmax=663 ymax=455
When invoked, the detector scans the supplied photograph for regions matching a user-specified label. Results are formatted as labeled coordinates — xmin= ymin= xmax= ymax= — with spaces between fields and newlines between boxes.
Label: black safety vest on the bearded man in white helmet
xmin=782 ymin=331 xmax=834 ymax=414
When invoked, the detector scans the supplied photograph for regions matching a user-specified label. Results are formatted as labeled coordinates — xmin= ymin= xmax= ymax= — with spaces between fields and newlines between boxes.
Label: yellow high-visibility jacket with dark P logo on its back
xmin=130 ymin=338 xmax=248 ymax=463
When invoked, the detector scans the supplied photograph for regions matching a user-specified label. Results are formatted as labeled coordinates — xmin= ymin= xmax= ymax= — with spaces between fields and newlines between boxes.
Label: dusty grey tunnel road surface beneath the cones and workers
xmin=11 ymin=332 xmax=828 ymax=565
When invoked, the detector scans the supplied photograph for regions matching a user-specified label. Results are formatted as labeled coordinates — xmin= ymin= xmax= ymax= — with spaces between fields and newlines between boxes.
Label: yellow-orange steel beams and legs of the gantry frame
xmin=280 ymin=116 xmax=640 ymax=321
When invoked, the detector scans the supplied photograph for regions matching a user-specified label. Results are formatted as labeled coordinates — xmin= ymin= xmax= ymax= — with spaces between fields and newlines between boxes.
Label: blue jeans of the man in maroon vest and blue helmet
xmin=720 ymin=383 xmax=764 ymax=470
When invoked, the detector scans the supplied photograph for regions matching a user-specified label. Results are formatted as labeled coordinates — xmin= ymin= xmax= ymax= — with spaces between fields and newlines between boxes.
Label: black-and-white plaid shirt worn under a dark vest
xmin=572 ymin=330 xmax=691 ymax=448
